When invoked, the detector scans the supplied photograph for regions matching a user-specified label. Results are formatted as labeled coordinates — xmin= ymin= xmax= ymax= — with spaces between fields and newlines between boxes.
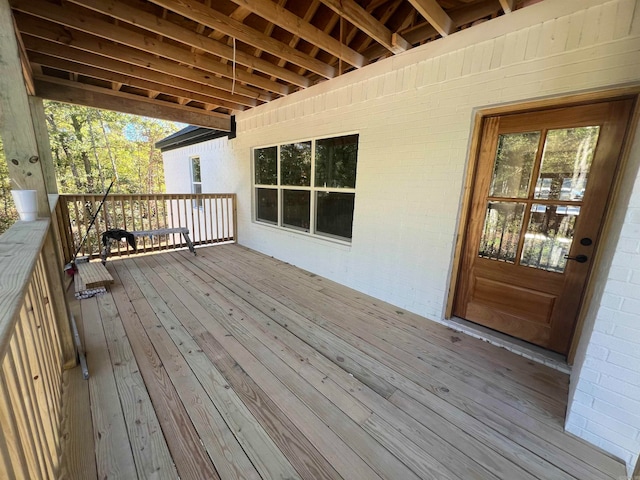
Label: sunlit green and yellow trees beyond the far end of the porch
xmin=0 ymin=101 xmax=184 ymax=233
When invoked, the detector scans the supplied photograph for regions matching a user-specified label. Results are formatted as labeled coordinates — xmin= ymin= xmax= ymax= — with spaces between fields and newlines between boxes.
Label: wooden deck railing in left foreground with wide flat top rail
xmin=0 ymin=219 xmax=73 ymax=479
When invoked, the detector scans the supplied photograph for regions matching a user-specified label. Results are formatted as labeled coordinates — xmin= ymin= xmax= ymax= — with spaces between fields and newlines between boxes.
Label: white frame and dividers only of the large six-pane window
xmin=251 ymin=132 xmax=360 ymax=245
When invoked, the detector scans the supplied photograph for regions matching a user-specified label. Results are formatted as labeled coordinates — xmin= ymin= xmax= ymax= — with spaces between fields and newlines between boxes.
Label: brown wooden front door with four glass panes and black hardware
xmin=453 ymin=100 xmax=632 ymax=354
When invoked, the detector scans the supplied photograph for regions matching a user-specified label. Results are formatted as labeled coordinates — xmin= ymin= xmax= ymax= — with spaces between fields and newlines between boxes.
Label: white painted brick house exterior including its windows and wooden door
xmin=160 ymin=0 xmax=640 ymax=472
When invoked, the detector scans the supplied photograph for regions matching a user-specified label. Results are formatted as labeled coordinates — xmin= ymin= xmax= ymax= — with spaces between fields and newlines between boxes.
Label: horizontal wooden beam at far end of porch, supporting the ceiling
xmin=35 ymin=77 xmax=231 ymax=132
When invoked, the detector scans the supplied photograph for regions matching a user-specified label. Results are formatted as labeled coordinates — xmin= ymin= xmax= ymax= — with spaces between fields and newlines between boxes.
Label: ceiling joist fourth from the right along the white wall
xmin=226 ymin=0 xmax=366 ymax=68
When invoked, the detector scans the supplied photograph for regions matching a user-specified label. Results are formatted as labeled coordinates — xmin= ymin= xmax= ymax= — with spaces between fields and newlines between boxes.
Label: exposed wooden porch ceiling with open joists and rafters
xmin=9 ymin=0 xmax=537 ymax=130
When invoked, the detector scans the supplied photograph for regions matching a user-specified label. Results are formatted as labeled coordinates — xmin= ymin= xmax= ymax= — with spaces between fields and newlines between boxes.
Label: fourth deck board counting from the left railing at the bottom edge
xmin=111 ymin=271 xmax=220 ymax=480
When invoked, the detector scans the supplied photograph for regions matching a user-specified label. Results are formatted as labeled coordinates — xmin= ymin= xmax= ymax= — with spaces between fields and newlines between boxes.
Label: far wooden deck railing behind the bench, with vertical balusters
xmin=59 ymin=193 xmax=237 ymax=262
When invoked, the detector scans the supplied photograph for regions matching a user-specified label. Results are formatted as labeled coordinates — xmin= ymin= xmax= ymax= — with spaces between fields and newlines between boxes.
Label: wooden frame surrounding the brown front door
xmin=444 ymin=85 xmax=640 ymax=365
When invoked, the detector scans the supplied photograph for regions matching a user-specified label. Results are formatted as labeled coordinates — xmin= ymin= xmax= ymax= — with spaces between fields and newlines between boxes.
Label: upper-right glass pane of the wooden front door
xmin=535 ymin=126 xmax=600 ymax=201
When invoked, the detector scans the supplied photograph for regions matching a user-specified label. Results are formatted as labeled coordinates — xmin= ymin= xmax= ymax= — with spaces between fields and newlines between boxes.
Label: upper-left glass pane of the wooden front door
xmin=489 ymin=132 xmax=540 ymax=198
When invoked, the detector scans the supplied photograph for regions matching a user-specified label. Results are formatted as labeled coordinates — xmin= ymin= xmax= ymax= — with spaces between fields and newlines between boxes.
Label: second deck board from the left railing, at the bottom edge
xmin=81 ymin=298 xmax=137 ymax=479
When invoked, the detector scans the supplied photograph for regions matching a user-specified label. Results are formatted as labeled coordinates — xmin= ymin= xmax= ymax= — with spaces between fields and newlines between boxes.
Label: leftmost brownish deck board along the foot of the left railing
xmin=60 ymin=366 xmax=98 ymax=480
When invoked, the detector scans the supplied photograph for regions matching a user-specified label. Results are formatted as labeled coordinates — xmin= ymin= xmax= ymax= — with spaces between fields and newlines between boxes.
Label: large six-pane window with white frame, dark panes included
xmin=253 ymin=134 xmax=358 ymax=240
